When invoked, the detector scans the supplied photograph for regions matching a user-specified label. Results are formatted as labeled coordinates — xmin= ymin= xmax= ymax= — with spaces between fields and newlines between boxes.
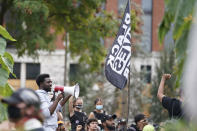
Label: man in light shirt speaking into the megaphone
xmin=36 ymin=74 xmax=71 ymax=131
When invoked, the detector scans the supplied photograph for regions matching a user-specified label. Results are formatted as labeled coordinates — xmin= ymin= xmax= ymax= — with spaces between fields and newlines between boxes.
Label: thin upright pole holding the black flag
xmin=126 ymin=0 xmax=132 ymax=126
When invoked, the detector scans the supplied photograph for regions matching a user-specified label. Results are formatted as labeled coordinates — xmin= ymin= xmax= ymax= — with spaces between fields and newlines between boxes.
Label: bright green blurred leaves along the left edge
xmin=0 ymin=25 xmax=16 ymax=122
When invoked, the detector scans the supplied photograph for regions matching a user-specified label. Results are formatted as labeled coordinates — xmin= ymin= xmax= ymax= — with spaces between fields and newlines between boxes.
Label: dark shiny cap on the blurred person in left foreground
xmin=1 ymin=88 xmax=40 ymax=107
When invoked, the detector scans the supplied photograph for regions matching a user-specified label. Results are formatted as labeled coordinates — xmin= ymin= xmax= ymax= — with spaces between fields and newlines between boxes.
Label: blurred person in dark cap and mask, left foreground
xmin=1 ymin=88 xmax=44 ymax=131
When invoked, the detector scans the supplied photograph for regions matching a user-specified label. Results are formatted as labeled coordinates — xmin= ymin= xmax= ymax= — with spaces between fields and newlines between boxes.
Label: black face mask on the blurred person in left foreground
xmin=8 ymin=105 xmax=22 ymax=120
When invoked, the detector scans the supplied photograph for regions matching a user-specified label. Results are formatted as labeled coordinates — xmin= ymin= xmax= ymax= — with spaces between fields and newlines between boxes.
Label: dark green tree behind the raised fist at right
xmin=149 ymin=50 xmax=177 ymax=123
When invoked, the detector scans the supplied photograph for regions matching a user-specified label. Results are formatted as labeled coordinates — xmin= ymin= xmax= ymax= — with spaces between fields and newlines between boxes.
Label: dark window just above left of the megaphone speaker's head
xmin=26 ymin=63 xmax=40 ymax=80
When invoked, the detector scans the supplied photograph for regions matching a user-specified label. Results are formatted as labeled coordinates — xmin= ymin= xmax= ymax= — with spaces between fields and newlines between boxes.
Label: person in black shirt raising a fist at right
xmin=157 ymin=74 xmax=183 ymax=119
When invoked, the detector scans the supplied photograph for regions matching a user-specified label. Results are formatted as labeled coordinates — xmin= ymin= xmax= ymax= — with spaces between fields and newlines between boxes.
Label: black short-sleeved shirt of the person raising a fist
xmin=162 ymin=96 xmax=183 ymax=118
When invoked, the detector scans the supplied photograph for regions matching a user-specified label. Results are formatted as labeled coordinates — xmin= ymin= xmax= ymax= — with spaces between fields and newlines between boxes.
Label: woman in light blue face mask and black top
xmin=88 ymin=98 xmax=106 ymax=129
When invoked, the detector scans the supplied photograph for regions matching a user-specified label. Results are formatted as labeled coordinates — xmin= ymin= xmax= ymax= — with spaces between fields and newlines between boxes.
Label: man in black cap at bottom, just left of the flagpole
xmin=103 ymin=114 xmax=117 ymax=131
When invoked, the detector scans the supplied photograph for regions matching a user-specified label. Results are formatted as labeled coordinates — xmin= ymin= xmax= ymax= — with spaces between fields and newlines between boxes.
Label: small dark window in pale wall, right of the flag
xmin=141 ymin=65 xmax=151 ymax=83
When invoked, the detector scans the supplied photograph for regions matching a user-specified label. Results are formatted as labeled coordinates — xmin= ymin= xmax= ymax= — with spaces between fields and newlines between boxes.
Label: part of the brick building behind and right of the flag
xmin=105 ymin=0 xmax=165 ymax=83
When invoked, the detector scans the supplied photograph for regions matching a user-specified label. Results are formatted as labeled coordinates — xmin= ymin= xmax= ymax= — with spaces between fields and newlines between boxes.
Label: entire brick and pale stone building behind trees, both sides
xmin=9 ymin=0 xmax=164 ymax=89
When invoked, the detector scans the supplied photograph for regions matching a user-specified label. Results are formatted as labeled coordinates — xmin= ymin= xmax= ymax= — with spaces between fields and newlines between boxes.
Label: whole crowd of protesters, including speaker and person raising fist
xmin=0 ymin=74 xmax=184 ymax=131
